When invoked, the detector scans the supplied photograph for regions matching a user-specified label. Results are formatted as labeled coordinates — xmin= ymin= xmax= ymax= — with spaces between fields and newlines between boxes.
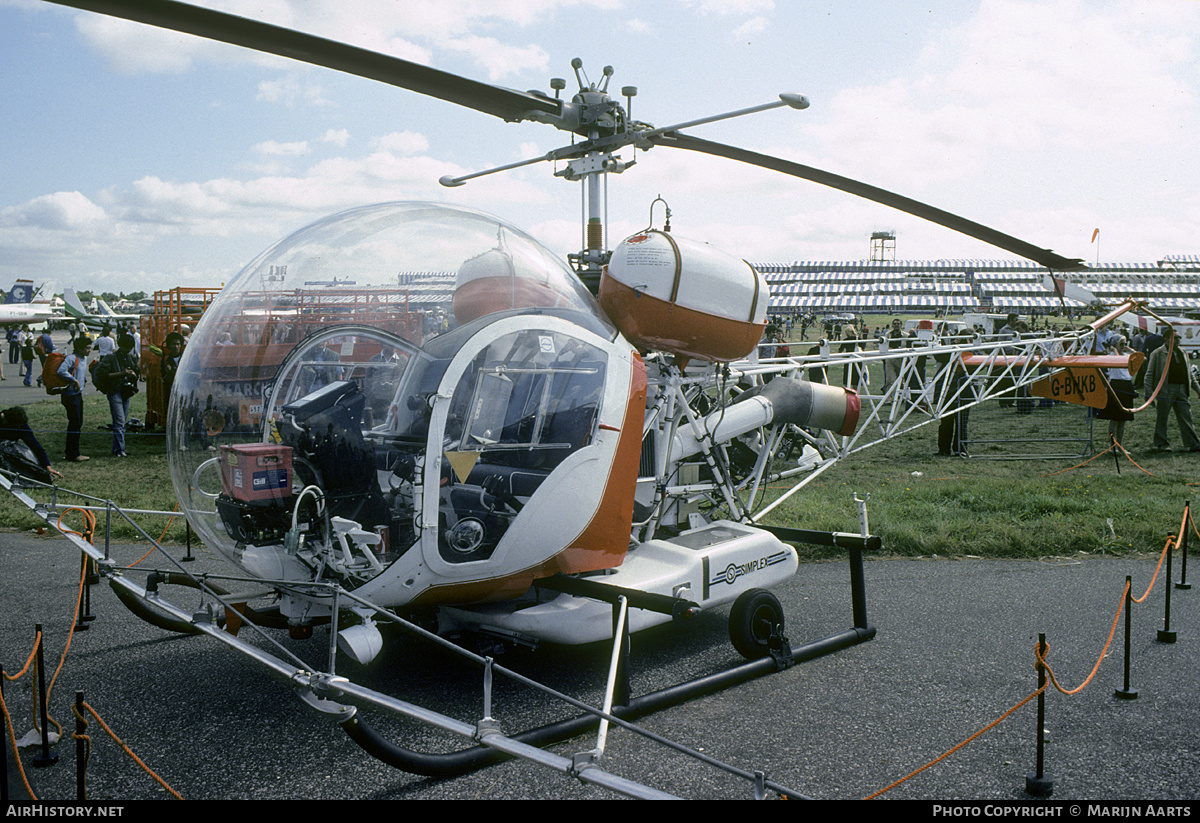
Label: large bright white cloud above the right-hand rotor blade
xmin=793 ymin=0 xmax=1200 ymax=259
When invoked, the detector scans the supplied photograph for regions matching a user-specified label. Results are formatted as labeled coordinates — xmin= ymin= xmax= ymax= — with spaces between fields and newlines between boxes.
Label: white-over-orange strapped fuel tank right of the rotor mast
xmin=600 ymin=229 xmax=770 ymax=361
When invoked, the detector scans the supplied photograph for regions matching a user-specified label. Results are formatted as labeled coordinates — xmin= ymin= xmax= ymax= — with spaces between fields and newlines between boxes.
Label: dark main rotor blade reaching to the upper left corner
xmin=48 ymin=0 xmax=562 ymax=121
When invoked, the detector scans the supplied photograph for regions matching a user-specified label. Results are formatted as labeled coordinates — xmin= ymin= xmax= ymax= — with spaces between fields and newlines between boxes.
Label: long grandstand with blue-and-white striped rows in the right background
xmin=755 ymin=256 xmax=1200 ymax=314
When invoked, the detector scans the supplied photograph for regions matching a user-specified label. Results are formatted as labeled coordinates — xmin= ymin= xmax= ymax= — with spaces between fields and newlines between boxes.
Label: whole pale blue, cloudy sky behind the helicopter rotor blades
xmin=0 ymin=0 xmax=1200 ymax=293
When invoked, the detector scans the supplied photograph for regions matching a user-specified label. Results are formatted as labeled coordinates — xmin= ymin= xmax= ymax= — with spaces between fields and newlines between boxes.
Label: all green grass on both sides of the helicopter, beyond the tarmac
xmin=0 ymin=345 xmax=1200 ymax=558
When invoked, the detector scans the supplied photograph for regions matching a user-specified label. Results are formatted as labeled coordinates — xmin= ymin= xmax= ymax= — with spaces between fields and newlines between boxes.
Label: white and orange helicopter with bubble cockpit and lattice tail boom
xmin=25 ymin=0 xmax=1142 ymax=662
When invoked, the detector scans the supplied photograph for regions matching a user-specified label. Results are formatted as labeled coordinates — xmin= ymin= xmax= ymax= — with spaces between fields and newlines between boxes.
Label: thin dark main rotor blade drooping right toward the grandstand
xmin=650 ymin=132 xmax=1087 ymax=271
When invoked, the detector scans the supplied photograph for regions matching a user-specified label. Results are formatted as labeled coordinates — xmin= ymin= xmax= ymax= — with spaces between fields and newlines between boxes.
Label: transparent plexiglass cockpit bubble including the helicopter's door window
xmin=167 ymin=203 xmax=616 ymax=584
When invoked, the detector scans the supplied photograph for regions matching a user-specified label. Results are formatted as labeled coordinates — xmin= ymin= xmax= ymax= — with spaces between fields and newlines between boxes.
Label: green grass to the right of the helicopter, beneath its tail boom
xmin=768 ymin=403 xmax=1200 ymax=558
